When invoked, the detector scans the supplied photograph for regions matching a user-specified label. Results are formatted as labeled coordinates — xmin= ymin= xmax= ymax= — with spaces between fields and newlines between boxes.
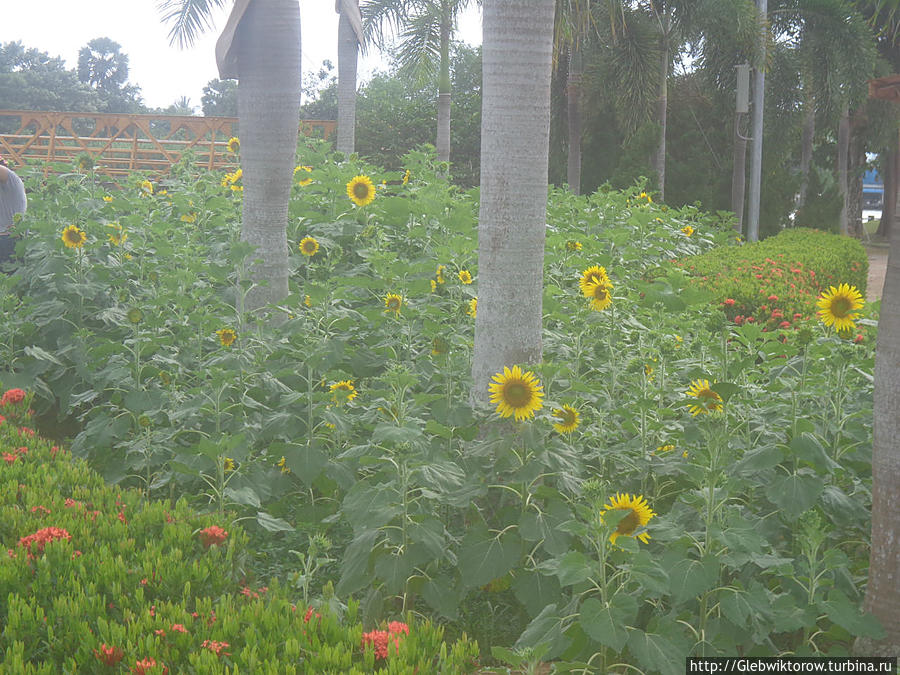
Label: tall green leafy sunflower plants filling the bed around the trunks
xmin=0 ymin=154 xmax=875 ymax=672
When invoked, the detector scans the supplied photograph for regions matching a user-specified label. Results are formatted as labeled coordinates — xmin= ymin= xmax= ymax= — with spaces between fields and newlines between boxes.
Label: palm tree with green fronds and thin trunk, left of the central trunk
xmin=363 ymin=0 xmax=481 ymax=162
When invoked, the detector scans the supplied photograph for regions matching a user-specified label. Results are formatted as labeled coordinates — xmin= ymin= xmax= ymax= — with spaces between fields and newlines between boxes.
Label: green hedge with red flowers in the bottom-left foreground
xmin=0 ymin=396 xmax=478 ymax=674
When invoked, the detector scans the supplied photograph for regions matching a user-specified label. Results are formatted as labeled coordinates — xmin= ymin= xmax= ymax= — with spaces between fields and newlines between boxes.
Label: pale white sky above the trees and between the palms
xmin=0 ymin=0 xmax=481 ymax=110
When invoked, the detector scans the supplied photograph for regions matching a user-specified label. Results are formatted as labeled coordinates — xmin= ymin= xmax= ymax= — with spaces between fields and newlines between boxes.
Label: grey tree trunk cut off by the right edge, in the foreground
xmin=856 ymin=206 xmax=900 ymax=656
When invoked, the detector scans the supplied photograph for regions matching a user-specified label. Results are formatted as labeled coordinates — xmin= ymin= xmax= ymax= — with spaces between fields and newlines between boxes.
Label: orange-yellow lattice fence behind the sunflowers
xmin=0 ymin=110 xmax=337 ymax=177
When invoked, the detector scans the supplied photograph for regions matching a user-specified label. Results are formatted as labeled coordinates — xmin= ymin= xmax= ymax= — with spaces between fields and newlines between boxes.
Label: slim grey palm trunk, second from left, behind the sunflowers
xmin=334 ymin=0 xmax=365 ymax=155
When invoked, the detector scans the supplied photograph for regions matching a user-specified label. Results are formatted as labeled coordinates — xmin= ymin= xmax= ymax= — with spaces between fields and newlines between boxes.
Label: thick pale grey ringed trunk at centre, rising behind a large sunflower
xmin=472 ymin=0 xmax=554 ymax=403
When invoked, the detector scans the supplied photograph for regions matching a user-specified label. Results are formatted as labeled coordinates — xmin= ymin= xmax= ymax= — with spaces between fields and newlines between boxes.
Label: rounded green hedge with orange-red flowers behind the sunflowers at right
xmin=676 ymin=228 xmax=869 ymax=328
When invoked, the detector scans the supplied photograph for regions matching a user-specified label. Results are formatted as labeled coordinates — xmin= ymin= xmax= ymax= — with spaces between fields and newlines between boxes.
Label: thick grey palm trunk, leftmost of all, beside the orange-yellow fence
xmin=236 ymin=0 xmax=300 ymax=311
